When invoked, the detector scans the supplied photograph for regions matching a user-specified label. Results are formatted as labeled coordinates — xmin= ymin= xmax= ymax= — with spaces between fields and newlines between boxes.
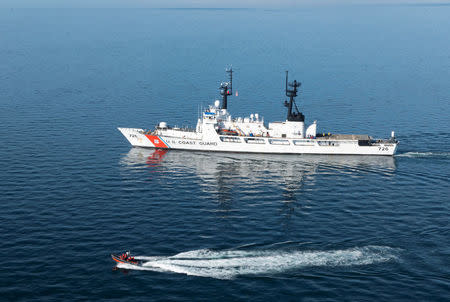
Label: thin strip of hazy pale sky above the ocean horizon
xmin=0 ymin=0 xmax=450 ymax=8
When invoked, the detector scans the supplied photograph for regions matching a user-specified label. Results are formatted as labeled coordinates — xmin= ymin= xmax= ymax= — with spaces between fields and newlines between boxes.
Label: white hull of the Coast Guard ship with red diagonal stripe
xmin=118 ymin=128 xmax=397 ymax=156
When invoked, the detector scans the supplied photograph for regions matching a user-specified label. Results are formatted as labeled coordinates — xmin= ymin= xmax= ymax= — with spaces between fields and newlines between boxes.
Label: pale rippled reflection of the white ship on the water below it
xmin=121 ymin=147 xmax=396 ymax=206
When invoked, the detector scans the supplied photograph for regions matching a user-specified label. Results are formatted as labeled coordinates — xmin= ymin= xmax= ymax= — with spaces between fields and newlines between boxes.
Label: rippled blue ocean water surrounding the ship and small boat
xmin=0 ymin=5 xmax=450 ymax=301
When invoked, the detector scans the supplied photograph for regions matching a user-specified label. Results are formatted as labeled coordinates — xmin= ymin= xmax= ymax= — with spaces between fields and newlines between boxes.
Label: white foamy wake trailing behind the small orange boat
xmin=118 ymin=246 xmax=398 ymax=279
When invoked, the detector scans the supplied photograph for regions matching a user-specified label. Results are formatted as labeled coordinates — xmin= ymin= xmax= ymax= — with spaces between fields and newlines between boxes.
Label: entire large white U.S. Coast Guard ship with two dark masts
xmin=118 ymin=68 xmax=398 ymax=155
